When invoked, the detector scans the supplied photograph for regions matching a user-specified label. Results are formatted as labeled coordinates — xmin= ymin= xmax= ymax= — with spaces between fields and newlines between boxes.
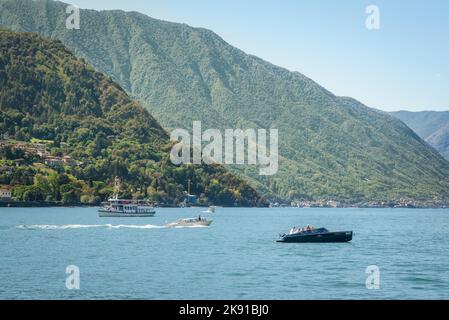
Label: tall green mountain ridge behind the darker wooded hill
xmin=0 ymin=0 xmax=449 ymax=201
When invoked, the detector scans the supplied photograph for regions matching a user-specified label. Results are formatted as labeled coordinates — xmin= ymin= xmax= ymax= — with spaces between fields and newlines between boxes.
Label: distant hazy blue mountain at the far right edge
xmin=391 ymin=111 xmax=449 ymax=160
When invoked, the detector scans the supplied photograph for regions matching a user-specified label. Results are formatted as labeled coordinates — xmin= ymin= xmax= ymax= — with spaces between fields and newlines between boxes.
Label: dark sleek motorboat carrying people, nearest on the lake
xmin=277 ymin=228 xmax=353 ymax=242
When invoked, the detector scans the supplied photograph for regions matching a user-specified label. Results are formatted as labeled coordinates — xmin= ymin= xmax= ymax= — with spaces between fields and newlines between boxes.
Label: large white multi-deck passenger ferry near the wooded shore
xmin=98 ymin=197 xmax=156 ymax=218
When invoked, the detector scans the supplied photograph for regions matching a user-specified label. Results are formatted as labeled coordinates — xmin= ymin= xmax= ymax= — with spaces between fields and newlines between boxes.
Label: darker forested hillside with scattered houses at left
xmin=0 ymin=30 xmax=264 ymax=206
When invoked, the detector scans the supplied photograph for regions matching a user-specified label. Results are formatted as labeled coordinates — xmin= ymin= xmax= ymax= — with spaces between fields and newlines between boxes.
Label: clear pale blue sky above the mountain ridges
xmin=64 ymin=0 xmax=449 ymax=111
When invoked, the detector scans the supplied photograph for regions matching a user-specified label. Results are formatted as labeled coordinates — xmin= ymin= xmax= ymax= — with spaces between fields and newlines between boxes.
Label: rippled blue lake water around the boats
xmin=0 ymin=208 xmax=449 ymax=299
